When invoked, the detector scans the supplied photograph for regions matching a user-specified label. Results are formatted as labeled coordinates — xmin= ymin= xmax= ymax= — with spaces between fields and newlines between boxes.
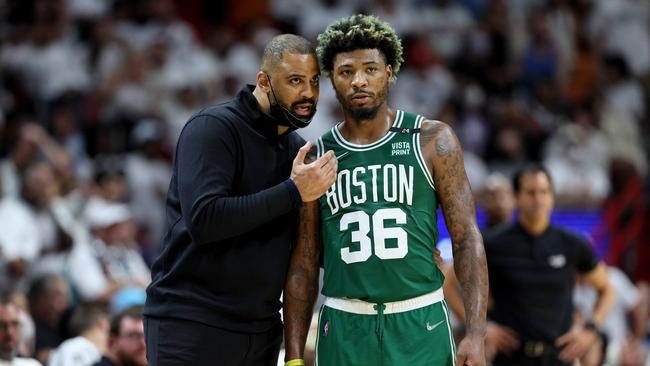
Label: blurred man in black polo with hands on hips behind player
xmin=485 ymin=165 xmax=614 ymax=366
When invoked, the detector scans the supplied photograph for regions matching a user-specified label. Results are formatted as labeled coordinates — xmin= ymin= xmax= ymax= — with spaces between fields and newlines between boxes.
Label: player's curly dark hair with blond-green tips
xmin=316 ymin=14 xmax=404 ymax=81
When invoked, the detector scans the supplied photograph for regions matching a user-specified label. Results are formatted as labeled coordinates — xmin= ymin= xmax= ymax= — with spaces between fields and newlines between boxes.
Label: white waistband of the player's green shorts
xmin=324 ymin=287 xmax=445 ymax=315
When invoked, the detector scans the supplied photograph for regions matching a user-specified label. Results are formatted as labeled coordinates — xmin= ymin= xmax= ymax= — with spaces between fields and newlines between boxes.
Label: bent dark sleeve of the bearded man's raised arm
xmin=176 ymin=115 xmax=295 ymax=244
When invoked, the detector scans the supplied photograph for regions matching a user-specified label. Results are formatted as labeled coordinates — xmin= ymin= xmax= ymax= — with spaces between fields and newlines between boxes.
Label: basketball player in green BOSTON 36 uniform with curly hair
xmin=284 ymin=15 xmax=488 ymax=366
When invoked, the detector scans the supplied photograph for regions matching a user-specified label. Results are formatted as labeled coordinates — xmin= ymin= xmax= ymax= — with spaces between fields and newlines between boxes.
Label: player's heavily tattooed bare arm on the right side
xmin=420 ymin=121 xmax=488 ymax=335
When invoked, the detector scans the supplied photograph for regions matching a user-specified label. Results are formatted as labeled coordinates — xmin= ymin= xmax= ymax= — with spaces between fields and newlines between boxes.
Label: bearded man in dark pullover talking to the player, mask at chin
xmin=144 ymin=35 xmax=336 ymax=366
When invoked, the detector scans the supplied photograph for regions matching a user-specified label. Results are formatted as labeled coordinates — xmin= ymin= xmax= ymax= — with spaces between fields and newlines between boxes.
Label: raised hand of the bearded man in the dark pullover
xmin=291 ymin=141 xmax=338 ymax=202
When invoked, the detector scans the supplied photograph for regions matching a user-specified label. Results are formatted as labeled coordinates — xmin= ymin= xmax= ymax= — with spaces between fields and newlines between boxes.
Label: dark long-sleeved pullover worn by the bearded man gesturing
xmin=144 ymin=85 xmax=304 ymax=332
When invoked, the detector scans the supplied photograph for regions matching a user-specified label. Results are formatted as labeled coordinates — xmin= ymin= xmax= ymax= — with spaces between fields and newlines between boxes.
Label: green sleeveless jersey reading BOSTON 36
xmin=317 ymin=111 xmax=444 ymax=303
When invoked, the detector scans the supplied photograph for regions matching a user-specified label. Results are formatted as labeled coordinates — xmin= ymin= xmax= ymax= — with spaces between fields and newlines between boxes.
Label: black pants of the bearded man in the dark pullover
xmin=144 ymin=317 xmax=282 ymax=366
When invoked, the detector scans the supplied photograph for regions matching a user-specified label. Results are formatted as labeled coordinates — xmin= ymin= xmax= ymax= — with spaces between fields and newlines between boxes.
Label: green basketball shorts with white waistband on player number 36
xmin=316 ymin=288 xmax=456 ymax=366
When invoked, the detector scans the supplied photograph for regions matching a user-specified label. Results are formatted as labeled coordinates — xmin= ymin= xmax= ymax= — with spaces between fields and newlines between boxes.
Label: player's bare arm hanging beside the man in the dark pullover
xmin=283 ymin=201 xmax=321 ymax=361
